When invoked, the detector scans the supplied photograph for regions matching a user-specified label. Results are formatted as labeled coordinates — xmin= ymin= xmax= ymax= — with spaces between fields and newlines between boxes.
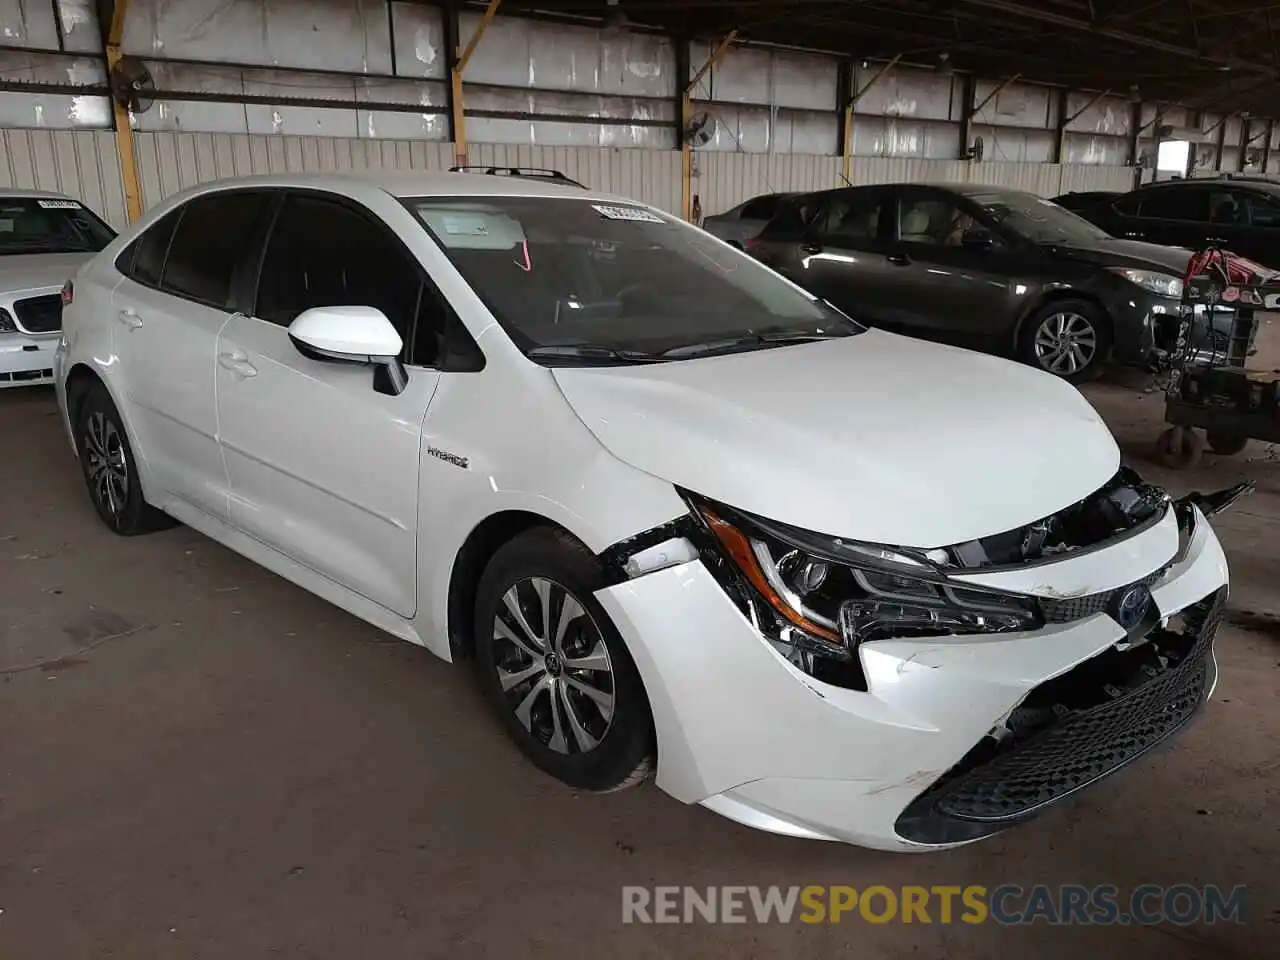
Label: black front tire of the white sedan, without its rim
xmin=475 ymin=527 xmax=653 ymax=791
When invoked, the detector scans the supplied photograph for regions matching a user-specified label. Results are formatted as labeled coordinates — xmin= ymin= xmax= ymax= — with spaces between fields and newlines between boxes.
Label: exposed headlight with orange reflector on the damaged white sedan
xmin=687 ymin=495 xmax=1044 ymax=689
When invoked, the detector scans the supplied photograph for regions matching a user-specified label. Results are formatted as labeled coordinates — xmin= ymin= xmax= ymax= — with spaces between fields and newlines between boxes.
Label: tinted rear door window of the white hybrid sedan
xmin=160 ymin=191 xmax=270 ymax=308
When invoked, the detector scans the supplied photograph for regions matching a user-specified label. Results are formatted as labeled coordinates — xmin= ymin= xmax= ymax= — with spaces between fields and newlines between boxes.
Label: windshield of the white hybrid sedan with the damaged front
xmin=406 ymin=197 xmax=863 ymax=364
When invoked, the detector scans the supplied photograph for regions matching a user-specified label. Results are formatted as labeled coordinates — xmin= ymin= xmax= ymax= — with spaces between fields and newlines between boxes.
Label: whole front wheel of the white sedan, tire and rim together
xmin=475 ymin=527 xmax=654 ymax=792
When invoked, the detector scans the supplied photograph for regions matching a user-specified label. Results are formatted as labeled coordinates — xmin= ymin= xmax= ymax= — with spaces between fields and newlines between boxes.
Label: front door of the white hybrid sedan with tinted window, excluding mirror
xmin=216 ymin=193 xmax=443 ymax=617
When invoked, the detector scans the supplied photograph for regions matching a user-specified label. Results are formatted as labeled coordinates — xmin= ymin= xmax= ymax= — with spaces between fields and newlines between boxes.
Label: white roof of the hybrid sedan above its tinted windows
xmin=163 ymin=170 xmax=629 ymax=204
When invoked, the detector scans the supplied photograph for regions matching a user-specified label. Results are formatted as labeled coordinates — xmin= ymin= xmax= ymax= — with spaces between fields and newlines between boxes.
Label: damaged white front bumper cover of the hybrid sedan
xmin=596 ymin=499 xmax=1228 ymax=850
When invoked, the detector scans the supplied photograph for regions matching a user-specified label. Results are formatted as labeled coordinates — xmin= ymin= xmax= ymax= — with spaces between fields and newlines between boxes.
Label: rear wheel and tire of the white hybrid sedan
xmin=74 ymin=383 xmax=174 ymax=536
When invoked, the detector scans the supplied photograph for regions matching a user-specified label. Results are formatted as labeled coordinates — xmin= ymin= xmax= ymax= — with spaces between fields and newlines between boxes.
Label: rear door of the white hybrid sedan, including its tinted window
xmin=111 ymin=191 xmax=269 ymax=521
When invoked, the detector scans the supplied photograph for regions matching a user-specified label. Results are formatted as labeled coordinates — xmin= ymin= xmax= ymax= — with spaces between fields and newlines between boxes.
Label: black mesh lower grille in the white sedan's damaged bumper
xmin=897 ymin=590 xmax=1225 ymax=844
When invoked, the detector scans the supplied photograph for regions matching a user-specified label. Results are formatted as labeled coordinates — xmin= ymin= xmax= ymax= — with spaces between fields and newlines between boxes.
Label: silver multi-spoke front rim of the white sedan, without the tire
xmin=493 ymin=577 xmax=614 ymax=754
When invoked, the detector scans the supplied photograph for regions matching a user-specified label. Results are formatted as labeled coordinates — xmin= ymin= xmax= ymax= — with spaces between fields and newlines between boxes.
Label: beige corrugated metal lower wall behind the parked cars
xmin=0 ymin=129 xmax=1133 ymax=227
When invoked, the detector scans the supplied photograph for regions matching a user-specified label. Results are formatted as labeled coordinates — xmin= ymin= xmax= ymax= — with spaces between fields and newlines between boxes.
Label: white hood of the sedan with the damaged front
xmin=553 ymin=330 xmax=1120 ymax=548
